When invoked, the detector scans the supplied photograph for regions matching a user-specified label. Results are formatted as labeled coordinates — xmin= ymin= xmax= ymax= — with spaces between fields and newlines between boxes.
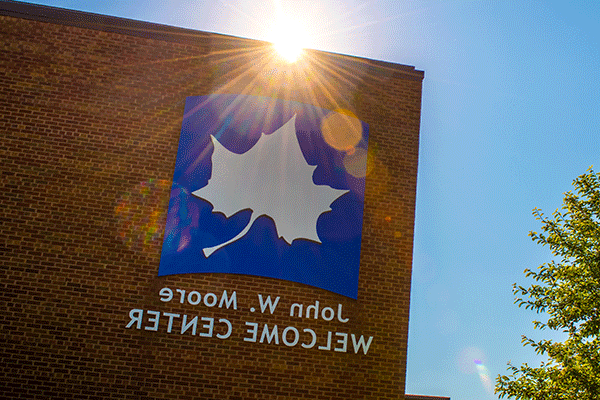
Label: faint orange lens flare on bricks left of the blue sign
xmin=115 ymin=179 xmax=170 ymax=250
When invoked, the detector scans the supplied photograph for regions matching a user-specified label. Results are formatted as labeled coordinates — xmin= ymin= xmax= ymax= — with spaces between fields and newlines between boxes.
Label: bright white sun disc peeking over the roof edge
xmin=270 ymin=16 xmax=308 ymax=63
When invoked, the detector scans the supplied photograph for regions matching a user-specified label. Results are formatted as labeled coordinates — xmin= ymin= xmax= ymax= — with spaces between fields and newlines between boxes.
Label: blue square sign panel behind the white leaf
xmin=158 ymin=94 xmax=368 ymax=298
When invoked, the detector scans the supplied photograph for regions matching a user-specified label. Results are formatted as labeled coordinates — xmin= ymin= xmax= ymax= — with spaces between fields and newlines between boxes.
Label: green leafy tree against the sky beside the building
xmin=496 ymin=168 xmax=600 ymax=400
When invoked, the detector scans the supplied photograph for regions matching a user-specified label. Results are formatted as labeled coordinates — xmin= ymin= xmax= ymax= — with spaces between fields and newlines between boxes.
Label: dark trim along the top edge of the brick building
xmin=0 ymin=0 xmax=424 ymax=79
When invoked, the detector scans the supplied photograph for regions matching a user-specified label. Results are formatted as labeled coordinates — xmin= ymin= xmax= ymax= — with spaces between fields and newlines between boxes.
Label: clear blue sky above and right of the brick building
xmin=23 ymin=0 xmax=600 ymax=400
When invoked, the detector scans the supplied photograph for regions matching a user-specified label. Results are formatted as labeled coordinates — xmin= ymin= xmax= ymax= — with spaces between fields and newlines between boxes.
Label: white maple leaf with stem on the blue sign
xmin=192 ymin=115 xmax=348 ymax=257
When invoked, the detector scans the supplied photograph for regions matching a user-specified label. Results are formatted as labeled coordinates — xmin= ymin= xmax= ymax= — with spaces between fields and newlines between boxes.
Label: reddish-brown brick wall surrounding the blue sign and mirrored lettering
xmin=0 ymin=3 xmax=423 ymax=399
